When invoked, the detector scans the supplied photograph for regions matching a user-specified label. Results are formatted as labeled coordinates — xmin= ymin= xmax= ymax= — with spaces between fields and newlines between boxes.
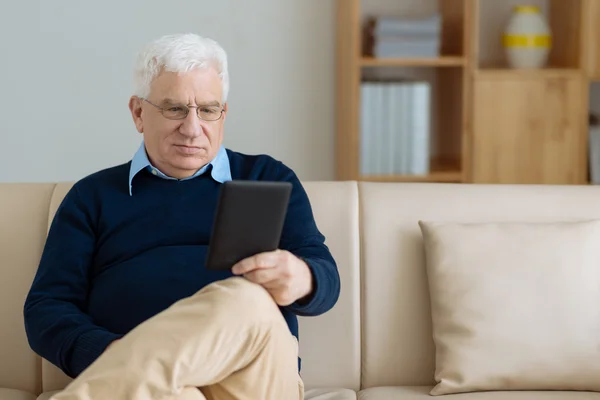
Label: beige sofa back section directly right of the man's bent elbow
xmin=290 ymin=182 xmax=361 ymax=390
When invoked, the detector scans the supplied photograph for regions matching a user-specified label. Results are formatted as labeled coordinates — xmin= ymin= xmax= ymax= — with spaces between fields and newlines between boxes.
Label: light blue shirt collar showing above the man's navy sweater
xmin=129 ymin=140 xmax=231 ymax=196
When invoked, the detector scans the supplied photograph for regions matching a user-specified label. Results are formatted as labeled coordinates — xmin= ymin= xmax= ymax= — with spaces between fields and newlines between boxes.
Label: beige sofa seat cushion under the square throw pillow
xmin=358 ymin=386 xmax=600 ymax=400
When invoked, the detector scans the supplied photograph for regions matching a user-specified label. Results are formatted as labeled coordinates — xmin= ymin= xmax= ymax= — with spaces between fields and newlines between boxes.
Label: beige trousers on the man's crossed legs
xmin=51 ymin=277 xmax=304 ymax=400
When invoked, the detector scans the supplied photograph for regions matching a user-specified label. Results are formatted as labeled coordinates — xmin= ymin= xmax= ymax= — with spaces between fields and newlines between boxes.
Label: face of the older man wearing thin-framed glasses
xmin=129 ymin=68 xmax=227 ymax=179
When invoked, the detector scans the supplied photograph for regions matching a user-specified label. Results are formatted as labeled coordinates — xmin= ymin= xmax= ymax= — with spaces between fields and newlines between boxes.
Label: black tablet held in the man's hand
xmin=206 ymin=180 xmax=292 ymax=270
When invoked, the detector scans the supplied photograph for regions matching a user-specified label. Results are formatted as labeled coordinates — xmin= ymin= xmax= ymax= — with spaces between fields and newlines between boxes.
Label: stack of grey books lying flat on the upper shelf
xmin=365 ymin=14 xmax=442 ymax=58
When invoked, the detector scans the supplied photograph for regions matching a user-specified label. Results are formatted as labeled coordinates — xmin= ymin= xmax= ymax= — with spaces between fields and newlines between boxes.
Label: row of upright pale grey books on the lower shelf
xmin=360 ymin=80 xmax=431 ymax=175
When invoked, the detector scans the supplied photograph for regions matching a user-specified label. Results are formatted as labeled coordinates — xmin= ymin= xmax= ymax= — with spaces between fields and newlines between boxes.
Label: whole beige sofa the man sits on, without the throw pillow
xmin=0 ymin=182 xmax=600 ymax=400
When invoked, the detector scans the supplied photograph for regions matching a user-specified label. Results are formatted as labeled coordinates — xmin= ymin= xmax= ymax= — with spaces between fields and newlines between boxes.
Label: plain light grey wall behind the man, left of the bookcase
xmin=0 ymin=0 xmax=335 ymax=182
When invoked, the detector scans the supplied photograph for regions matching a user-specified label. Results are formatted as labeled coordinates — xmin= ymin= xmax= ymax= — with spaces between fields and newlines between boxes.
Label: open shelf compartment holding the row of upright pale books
xmin=355 ymin=67 xmax=465 ymax=182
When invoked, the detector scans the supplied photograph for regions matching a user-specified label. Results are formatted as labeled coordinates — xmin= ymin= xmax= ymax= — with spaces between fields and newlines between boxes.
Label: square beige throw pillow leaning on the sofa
xmin=420 ymin=220 xmax=600 ymax=395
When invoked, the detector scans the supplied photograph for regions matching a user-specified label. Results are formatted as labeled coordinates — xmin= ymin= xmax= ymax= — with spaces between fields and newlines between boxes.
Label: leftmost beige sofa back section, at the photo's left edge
xmin=0 ymin=183 xmax=54 ymax=393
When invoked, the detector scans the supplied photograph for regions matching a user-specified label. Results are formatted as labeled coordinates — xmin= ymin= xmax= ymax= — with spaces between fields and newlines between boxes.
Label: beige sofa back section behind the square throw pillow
xmin=359 ymin=182 xmax=600 ymax=388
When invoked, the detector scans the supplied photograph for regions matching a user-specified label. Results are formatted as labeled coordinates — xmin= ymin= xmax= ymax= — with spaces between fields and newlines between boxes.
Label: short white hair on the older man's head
xmin=134 ymin=33 xmax=229 ymax=103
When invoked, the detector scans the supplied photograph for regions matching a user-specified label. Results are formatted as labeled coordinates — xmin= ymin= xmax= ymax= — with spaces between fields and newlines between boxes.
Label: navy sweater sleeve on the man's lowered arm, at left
xmin=24 ymin=186 xmax=120 ymax=378
